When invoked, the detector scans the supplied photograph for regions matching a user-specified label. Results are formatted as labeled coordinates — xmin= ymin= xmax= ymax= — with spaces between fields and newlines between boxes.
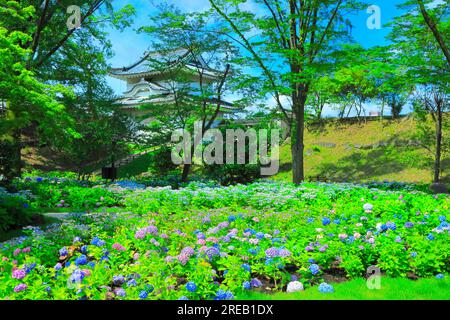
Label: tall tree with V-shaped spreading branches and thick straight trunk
xmin=210 ymin=0 xmax=360 ymax=183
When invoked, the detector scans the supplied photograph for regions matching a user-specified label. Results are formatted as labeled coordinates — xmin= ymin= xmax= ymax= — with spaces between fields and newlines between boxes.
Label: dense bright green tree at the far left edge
xmin=0 ymin=0 xmax=134 ymax=179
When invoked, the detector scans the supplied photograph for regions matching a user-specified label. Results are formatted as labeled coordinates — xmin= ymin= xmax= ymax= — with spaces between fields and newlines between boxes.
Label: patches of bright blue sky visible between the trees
xmin=108 ymin=0 xmax=403 ymax=115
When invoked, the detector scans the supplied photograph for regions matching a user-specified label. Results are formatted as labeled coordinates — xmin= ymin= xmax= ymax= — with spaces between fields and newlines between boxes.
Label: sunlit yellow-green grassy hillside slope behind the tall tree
xmin=273 ymin=117 xmax=450 ymax=183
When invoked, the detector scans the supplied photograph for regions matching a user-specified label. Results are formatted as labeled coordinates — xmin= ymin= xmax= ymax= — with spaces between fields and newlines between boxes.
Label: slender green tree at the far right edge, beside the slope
xmin=390 ymin=1 xmax=450 ymax=182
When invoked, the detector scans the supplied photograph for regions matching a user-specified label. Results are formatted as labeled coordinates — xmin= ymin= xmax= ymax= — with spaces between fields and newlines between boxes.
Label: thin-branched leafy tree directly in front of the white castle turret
xmin=141 ymin=5 xmax=239 ymax=181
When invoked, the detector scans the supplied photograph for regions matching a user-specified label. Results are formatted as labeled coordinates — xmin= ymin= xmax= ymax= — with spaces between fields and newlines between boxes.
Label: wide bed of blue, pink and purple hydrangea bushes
xmin=0 ymin=182 xmax=450 ymax=300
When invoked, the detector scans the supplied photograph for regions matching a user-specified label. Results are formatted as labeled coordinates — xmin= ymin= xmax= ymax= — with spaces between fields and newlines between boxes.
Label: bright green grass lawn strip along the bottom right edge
xmin=237 ymin=275 xmax=450 ymax=300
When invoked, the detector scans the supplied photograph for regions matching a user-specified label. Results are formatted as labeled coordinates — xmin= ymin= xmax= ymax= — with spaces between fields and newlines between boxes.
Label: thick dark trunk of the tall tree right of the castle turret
xmin=291 ymin=92 xmax=306 ymax=184
